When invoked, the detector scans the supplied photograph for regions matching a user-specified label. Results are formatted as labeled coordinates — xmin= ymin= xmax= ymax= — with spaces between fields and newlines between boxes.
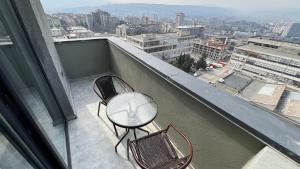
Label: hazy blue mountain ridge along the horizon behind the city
xmin=46 ymin=3 xmax=300 ymax=21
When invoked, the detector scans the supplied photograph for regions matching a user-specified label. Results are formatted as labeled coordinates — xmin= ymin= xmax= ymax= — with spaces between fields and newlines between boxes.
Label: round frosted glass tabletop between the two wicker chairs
xmin=106 ymin=92 xmax=157 ymax=128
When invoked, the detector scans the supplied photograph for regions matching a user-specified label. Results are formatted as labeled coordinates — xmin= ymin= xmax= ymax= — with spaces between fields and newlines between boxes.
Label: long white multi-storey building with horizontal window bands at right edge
xmin=230 ymin=37 xmax=300 ymax=87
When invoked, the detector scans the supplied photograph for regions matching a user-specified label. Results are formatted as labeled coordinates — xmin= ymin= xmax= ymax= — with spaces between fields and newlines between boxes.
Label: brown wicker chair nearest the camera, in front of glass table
xmin=127 ymin=124 xmax=193 ymax=169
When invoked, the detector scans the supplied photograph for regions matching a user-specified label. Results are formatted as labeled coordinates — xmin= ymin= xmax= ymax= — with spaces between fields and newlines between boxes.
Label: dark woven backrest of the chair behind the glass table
xmin=95 ymin=75 xmax=118 ymax=102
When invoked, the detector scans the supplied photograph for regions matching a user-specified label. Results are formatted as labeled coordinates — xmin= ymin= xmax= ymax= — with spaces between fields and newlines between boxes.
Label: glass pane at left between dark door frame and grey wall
xmin=0 ymin=15 xmax=67 ymax=163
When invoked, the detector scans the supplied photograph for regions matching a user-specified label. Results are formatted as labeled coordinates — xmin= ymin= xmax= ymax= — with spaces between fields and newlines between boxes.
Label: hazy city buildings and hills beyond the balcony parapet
xmin=47 ymin=3 xmax=300 ymax=122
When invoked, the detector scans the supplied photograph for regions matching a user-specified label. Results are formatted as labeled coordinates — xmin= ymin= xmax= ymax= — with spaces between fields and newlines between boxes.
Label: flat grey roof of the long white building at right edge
xmin=235 ymin=45 xmax=300 ymax=60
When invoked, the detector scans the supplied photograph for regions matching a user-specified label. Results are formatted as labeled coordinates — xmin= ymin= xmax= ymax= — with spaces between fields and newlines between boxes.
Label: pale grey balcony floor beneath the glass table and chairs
xmin=69 ymin=77 xmax=156 ymax=169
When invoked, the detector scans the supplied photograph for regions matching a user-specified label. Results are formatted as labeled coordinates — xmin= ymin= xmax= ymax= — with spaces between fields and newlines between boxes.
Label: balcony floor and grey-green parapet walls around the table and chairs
xmin=55 ymin=37 xmax=300 ymax=169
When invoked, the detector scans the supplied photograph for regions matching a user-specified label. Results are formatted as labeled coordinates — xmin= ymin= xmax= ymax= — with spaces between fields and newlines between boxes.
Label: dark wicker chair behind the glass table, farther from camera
xmin=93 ymin=73 xmax=134 ymax=137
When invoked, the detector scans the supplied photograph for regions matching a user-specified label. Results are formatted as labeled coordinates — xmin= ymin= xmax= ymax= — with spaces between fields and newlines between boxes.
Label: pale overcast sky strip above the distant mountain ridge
xmin=41 ymin=0 xmax=300 ymax=9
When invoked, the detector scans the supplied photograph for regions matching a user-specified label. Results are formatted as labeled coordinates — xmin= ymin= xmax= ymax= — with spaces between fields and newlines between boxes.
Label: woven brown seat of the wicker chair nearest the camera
xmin=133 ymin=132 xmax=180 ymax=169
